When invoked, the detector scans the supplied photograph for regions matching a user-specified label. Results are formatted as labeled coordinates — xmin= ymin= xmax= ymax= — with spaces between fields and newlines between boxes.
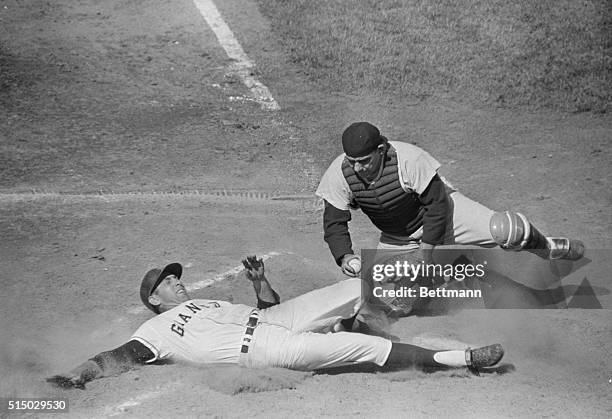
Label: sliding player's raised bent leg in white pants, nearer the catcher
xmin=261 ymin=278 xmax=368 ymax=332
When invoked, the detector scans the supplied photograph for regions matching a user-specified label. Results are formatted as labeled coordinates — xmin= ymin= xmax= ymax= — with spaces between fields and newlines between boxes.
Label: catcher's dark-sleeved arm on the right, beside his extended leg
xmin=419 ymin=174 xmax=449 ymax=263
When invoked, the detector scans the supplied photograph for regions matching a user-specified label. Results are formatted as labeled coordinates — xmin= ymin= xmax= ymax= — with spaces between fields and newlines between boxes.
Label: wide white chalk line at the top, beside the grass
xmin=193 ymin=0 xmax=280 ymax=111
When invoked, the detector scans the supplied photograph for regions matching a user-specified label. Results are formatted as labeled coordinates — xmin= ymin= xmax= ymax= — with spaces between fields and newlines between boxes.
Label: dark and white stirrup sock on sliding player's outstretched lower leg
xmin=385 ymin=342 xmax=466 ymax=368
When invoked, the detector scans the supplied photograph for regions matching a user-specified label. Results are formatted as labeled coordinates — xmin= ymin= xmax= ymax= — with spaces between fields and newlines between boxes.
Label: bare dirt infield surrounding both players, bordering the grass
xmin=0 ymin=0 xmax=612 ymax=418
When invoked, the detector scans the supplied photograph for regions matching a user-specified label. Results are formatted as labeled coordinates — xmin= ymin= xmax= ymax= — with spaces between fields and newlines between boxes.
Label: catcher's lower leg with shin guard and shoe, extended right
xmin=489 ymin=211 xmax=584 ymax=260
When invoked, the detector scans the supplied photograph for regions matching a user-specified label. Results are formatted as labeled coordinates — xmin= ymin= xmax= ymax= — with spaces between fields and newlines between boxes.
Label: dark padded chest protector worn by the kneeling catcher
xmin=342 ymin=146 xmax=425 ymax=236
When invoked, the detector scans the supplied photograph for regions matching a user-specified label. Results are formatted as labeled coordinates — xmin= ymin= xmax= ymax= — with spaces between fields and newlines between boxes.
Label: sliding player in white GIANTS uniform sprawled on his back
xmin=47 ymin=256 xmax=503 ymax=389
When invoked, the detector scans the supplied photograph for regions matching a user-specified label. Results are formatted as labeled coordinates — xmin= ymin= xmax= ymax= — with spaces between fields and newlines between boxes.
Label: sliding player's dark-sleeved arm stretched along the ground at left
xmin=46 ymin=340 xmax=155 ymax=389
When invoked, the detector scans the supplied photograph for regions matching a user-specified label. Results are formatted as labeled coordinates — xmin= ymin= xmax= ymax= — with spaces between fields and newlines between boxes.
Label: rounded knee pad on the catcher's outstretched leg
xmin=489 ymin=211 xmax=532 ymax=250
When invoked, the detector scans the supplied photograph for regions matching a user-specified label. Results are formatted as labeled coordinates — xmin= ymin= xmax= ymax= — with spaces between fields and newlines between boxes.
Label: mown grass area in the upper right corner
xmin=257 ymin=0 xmax=612 ymax=113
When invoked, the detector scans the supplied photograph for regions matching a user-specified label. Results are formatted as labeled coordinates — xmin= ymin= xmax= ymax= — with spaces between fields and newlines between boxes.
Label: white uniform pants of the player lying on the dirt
xmin=240 ymin=279 xmax=391 ymax=370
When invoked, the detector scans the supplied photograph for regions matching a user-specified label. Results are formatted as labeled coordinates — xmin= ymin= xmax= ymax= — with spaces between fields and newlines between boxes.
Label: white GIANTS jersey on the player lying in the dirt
xmin=132 ymin=299 xmax=253 ymax=363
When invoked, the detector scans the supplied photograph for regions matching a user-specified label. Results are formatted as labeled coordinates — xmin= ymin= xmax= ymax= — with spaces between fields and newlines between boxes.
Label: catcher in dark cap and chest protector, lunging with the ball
xmin=316 ymin=122 xmax=584 ymax=277
